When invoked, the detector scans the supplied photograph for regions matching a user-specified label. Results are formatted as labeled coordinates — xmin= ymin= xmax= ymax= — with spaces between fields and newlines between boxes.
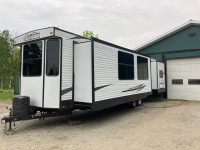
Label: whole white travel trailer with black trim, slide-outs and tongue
xmin=2 ymin=27 xmax=165 ymax=129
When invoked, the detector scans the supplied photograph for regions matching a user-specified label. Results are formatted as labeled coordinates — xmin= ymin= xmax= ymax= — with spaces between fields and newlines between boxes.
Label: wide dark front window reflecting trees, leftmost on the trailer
xmin=23 ymin=41 xmax=42 ymax=76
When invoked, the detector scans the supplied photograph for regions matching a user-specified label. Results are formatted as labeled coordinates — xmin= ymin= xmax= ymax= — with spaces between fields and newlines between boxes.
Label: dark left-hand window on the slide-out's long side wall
xmin=118 ymin=51 xmax=134 ymax=80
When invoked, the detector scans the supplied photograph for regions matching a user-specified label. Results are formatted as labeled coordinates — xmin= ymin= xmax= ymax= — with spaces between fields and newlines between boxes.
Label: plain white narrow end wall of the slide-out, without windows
xmin=74 ymin=42 xmax=92 ymax=104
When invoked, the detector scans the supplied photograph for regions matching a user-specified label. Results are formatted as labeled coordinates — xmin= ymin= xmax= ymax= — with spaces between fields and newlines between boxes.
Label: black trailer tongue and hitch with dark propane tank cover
xmin=1 ymin=96 xmax=73 ymax=131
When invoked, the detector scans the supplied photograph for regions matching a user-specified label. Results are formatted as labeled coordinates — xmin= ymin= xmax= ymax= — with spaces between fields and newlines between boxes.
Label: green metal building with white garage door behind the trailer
xmin=134 ymin=20 xmax=200 ymax=100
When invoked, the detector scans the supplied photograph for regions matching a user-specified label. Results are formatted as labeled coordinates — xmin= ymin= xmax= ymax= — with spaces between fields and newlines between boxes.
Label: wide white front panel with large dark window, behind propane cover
xmin=20 ymin=41 xmax=44 ymax=107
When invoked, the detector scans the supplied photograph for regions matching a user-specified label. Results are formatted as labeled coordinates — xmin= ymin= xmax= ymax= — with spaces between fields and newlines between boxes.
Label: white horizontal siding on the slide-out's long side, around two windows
xmin=94 ymin=42 xmax=151 ymax=101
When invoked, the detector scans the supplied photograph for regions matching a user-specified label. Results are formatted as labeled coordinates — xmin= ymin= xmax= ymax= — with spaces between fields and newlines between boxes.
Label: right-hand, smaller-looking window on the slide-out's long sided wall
xmin=137 ymin=56 xmax=148 ymax=80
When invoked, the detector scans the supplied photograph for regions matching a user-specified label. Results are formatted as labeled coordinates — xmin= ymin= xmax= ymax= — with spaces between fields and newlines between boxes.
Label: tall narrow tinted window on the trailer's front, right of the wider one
xmin=46 ymin=39 xmax=60 ymax=76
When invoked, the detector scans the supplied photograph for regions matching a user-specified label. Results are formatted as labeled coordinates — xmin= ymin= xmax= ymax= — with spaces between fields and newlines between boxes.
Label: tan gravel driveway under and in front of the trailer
xmin=0 ymin=101 xmax=200 ymax=150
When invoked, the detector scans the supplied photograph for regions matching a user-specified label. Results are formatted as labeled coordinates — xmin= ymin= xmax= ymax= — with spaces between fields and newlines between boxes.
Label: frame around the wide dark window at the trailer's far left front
xmin=21 ymin=40 xmax=44 ymax=77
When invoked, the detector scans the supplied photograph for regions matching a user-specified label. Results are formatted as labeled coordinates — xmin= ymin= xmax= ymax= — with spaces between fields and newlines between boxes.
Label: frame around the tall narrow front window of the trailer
xmin=45 ymin=38 xmax=61 ymax=77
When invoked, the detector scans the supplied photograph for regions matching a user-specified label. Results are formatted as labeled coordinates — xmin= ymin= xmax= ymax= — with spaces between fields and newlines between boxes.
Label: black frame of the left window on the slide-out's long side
xmin=117 ymin=51 xmax=135 ymax=81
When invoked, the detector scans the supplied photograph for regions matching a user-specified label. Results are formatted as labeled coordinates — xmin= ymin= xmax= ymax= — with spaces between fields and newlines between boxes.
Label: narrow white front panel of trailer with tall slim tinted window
xmin=44 ymin=39 xmax=61 ymax=108
